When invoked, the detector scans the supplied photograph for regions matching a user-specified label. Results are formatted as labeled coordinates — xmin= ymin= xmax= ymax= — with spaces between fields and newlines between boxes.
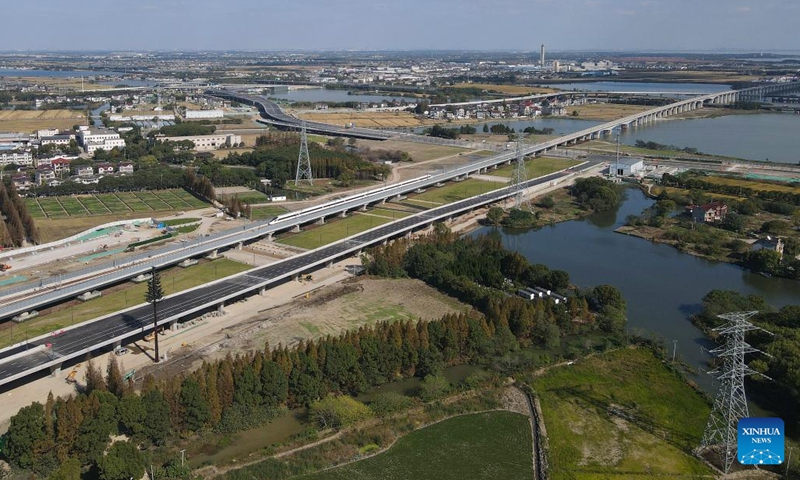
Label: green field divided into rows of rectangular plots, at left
xmin=25 ymin=188 xmax=208 ymax=219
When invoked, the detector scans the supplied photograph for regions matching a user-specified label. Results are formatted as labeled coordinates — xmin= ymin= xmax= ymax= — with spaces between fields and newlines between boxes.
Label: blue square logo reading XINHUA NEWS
xmin=737 ymin=418 xmax=784 ymax=465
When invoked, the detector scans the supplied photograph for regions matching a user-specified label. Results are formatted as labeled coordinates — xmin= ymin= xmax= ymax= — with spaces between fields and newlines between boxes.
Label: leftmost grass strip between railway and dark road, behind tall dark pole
xmin=0 ymin=258 xmax=251 ymax=348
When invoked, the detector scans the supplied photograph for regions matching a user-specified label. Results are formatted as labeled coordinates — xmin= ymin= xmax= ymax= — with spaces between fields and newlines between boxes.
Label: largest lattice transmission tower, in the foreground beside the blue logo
xmin=699 ymin=312 xmax=772 ymax=473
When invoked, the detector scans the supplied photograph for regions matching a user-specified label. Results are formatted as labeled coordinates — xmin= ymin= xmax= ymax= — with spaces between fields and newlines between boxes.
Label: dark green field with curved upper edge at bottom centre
xmin=300 ymin=412 xmax=533 ymax=480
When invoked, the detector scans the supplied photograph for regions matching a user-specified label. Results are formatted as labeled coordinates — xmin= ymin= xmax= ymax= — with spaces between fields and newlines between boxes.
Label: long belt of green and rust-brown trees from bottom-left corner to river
xmin=4 ymin=224 xmax=625 ymax=480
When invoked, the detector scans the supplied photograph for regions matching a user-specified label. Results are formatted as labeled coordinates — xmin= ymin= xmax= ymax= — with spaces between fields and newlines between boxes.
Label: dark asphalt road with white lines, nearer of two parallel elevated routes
xmin=0 ymin=162 xmax=597 ymax=385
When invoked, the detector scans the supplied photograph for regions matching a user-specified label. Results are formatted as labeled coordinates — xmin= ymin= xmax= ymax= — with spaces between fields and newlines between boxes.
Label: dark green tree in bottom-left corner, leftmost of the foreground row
xmin=3 ymin=402 xmax=45 ymax=468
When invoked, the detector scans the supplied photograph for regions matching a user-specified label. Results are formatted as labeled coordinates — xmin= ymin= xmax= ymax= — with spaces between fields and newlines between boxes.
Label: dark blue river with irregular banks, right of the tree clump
xmin=474 ymin=189 xmax=800 ymax=389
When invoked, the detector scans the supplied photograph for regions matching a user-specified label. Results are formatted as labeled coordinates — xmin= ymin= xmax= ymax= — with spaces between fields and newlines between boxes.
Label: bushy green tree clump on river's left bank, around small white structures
xmin=363 ymin=225 xmax=626 ymax=339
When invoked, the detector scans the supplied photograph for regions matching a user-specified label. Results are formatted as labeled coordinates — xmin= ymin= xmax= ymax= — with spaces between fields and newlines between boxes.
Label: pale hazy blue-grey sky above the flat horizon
xmin=0 ymin=0 xmax=800 ymax=51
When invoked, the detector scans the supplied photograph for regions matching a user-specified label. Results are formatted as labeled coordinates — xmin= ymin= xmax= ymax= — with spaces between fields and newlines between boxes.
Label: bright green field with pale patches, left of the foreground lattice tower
xmin=532 ymin=349 xmax=711 ymax=480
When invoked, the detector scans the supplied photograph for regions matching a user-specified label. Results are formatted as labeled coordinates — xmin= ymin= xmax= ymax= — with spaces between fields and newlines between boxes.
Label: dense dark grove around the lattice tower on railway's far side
xmin=222 ymin=135 xmax=389 ymax=188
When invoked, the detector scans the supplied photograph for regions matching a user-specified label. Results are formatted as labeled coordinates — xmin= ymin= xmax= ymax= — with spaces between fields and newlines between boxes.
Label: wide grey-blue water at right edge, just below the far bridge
xmin=620 ymin=113 xmax=800 ymax=163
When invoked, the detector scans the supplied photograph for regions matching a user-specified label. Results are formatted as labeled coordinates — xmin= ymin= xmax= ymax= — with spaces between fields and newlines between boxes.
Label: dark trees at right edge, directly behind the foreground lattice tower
xmin=692 ymin=290 xmax=800 ymax=431
